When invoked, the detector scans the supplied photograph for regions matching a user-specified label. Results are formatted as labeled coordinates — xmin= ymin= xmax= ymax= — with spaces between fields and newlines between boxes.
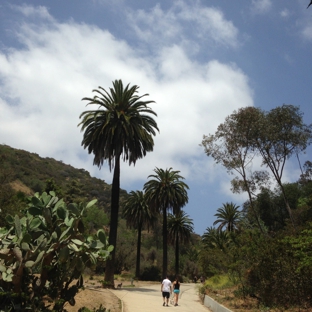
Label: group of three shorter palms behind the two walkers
xmin=124 ymin=172 xmax=194 ymax=278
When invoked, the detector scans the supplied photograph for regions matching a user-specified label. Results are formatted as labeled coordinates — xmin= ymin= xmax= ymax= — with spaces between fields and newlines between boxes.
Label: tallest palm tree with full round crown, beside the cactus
xmin=78 ymin=80 xmax=158 ymax=286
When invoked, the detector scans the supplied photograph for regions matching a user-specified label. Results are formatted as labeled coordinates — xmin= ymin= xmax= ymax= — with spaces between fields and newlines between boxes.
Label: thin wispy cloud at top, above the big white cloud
xmin=128 ymin=1 xmax=239 ymax=53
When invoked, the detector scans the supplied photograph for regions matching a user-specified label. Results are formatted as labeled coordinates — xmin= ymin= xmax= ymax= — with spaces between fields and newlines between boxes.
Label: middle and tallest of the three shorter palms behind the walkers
xmin=144 ymin=167 xmax=189 ymax=277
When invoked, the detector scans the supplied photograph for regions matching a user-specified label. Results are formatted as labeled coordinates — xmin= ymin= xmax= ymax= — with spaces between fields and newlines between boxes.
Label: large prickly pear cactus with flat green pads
xmin=0 ymin=192 xmax=113 ymax=311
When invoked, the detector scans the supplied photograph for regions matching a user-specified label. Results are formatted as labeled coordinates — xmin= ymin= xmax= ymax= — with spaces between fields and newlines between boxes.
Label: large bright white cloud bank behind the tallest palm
xmin=0 ymin=3 xmax=253 ymax=196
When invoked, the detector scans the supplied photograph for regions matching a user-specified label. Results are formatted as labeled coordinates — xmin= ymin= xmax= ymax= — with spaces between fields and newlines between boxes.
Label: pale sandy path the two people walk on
xmin=112 ymin=283 xmax=210 ymax=312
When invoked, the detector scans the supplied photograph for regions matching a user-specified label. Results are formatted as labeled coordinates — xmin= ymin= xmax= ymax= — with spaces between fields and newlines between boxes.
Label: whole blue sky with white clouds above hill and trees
xmin=0 ymin=0 xmax=312 ymax=235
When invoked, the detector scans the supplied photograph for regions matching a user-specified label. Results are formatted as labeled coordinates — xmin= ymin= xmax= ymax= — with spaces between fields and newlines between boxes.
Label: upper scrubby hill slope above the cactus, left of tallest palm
xmin=0 ymin=145 xmax=127 ymax=223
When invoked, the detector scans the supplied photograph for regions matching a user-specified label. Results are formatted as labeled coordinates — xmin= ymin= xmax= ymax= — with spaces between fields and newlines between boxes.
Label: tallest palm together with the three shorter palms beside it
xmin=78 ymin=80 xmax=193 ymax=286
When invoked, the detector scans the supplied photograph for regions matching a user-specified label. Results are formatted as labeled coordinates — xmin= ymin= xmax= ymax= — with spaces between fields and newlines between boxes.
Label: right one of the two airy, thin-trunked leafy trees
xmin=253 ymin=105 xmax=312 ymax=226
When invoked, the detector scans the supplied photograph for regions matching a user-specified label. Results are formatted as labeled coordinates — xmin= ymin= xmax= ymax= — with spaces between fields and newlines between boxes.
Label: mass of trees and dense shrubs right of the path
xmin=200 ymin=105 xmax=312 ymax=310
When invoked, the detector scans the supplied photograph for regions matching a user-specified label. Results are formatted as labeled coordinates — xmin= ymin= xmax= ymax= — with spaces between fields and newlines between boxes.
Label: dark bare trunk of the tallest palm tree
xmin=105 ymin=156 xmax=120 ymax=287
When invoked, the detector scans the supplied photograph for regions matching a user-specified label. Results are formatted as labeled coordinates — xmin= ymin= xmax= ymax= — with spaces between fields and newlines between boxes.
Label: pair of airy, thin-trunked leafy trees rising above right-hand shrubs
xmin=202 ymin=105 xmax=312 ymax=232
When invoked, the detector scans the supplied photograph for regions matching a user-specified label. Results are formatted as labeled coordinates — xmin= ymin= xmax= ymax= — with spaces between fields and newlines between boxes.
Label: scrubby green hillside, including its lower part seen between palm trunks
xmin=0 ymin=145 xmax=200 ymax=279
